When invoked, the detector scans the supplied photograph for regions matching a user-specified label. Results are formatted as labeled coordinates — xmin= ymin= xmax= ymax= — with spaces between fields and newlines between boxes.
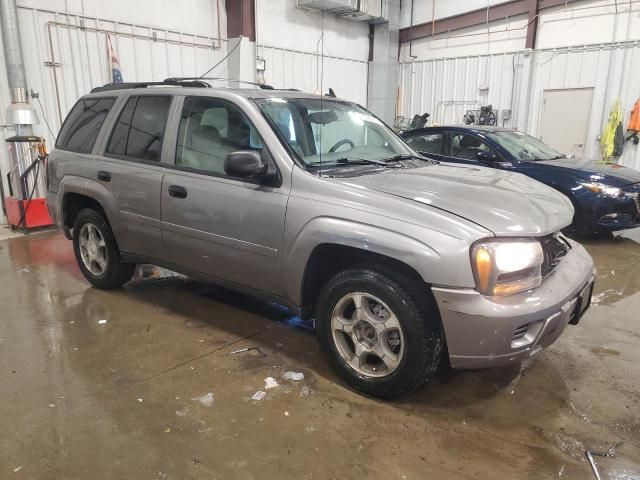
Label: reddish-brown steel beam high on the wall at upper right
xmin=400 ymin=0 xmax=583 ymax=43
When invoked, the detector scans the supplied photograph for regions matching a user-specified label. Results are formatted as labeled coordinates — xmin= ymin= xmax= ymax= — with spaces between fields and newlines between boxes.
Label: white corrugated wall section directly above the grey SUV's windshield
xmin=256 ymin=45 xmax=369 ymax=106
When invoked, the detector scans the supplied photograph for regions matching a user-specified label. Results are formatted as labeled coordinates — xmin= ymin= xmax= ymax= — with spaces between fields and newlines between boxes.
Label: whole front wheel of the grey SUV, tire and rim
xmin=316 ymin=266 xmax=443 ymax=399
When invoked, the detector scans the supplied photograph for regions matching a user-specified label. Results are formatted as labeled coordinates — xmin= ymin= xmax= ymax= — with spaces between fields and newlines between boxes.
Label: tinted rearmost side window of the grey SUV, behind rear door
xmin=56 ymin=98 xmax=115 ymax=153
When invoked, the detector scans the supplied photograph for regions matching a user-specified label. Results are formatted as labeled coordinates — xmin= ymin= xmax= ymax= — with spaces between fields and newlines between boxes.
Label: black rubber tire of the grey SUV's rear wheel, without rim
xmin=73 ymin=208 xmax=136 ymax=290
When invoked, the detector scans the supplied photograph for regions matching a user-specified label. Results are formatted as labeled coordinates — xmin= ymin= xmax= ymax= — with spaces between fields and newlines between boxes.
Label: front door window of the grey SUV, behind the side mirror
xmin=176 ymin=97 xmax=263 ymax=175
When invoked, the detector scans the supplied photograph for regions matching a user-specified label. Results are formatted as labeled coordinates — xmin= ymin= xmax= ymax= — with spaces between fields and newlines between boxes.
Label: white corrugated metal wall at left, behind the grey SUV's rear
xmin=0 ymin=7 xmax=227 ymax=224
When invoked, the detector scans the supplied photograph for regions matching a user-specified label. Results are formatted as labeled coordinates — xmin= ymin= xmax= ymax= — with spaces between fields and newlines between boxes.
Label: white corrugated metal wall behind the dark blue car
xmin=398 ymin=41 xmax=640 ymax=169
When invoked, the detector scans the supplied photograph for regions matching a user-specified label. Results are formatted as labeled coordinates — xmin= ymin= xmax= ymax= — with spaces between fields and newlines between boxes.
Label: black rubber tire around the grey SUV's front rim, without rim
xmin=316 ymin=265 xmax=444 ymax=399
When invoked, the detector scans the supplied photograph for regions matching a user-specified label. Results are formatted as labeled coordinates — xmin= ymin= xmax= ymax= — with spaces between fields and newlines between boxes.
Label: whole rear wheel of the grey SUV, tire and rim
xmin=73 ymin=208 xmax=136 ymax=290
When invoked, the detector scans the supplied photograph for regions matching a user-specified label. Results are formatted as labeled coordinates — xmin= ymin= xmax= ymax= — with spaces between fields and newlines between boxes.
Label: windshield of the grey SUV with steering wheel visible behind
xmin=258 ymin=98 xmax=417 ymax=167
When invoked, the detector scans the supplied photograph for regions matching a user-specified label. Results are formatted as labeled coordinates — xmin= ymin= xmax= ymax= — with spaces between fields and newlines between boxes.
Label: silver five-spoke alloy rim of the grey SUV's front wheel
xmin=331 ymin=292 xmax=405 ymax=377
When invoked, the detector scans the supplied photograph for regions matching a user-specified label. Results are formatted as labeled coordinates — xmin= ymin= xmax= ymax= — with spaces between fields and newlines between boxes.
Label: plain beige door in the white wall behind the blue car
xmin=540 ymin=88 xmax=593 ymax=157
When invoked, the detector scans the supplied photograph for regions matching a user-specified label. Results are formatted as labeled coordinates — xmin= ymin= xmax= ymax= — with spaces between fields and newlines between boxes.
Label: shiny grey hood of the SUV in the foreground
xmin=342 ymin=164 xmax=573 ymax=236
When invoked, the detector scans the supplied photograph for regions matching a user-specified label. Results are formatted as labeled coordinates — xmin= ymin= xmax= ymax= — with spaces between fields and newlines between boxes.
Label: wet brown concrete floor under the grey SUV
xmin=0 ymin=231 xmax=640 ymax=480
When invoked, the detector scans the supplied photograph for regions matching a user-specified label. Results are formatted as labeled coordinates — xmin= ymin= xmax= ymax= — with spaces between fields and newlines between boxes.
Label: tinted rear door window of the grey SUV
xmin=107 ymin=95 xmax=171 ymax=162
